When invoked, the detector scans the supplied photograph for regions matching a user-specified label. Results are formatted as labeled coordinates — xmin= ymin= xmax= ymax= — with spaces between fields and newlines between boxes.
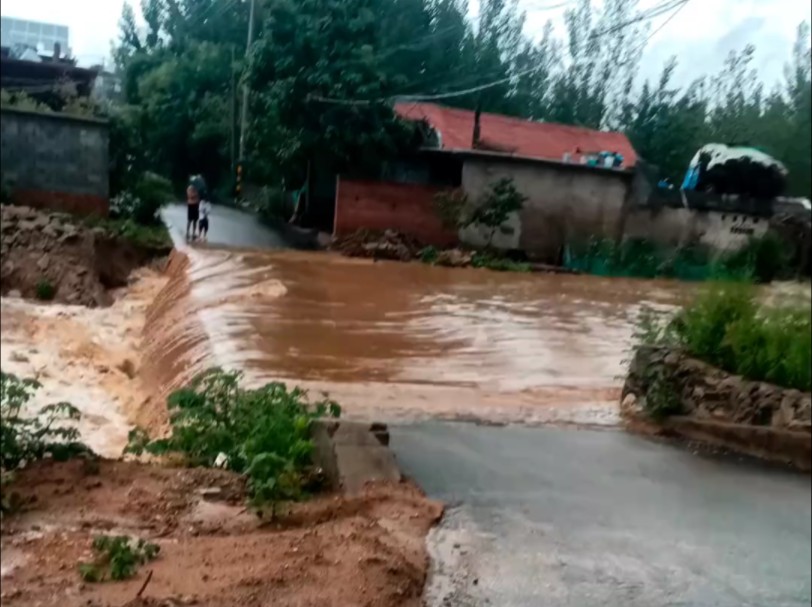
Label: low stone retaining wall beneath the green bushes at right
xmin=621 ymin=346 xmax=812 ymax=470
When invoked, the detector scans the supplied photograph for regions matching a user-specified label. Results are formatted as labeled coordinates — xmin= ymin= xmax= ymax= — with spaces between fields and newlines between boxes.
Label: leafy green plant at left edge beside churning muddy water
xmin=0 ymin=371 xmax=90 ymax=512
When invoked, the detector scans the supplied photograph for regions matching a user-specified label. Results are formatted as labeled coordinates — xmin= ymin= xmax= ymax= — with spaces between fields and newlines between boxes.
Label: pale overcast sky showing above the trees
xmin=2 ymin=0 xmax=812 ymax=89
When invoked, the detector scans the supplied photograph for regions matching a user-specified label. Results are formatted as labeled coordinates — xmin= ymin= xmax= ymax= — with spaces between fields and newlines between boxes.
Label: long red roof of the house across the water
xmin=395 ymin=102 xmax=637 ymax=168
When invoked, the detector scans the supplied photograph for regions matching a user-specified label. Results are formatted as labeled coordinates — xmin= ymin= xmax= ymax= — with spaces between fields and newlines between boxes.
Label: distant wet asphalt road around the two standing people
xmin=161 ymin=203 xmax=289 ymax=249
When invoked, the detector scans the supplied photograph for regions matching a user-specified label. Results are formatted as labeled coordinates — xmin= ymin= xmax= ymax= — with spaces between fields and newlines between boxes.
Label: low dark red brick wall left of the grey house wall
xmin=333 ymin=179 xmax=457 ymax=246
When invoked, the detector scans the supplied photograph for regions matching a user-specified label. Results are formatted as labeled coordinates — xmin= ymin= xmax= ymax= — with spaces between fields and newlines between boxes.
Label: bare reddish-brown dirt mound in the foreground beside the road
xmin=2 ymin=461 xmax=442 ymax=607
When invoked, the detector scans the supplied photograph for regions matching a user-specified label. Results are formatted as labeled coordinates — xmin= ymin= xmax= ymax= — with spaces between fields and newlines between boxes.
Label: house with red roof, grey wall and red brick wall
xmin=333 ymin=103 xmax=638 ymax=260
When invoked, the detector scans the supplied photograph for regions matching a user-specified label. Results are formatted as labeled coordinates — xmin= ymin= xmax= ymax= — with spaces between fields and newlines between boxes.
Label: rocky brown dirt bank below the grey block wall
xmin=0 ymin=205 xmax=171 ymax=307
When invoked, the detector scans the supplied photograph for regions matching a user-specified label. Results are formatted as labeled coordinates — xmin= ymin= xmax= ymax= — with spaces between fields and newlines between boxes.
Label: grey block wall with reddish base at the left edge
xmin=0 ymin=108 xmax=109 ymax=215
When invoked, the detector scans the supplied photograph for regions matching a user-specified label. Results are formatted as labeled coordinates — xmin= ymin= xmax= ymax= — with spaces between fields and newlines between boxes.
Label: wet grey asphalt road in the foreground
xmin=390 ymin=423 xmax=812 ymax=607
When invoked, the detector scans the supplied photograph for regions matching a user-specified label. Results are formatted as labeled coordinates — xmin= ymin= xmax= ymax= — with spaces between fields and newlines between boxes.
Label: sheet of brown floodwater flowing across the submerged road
xmin=146 ymin=248 xmax=692 ymax=423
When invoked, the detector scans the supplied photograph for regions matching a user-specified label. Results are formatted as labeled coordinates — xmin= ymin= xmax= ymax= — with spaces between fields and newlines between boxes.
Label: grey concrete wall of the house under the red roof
xmin=460 ymin=158 xmax=631 ymax=260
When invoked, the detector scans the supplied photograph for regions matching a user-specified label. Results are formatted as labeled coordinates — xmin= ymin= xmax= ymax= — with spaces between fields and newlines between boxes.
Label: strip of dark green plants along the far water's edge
xmin=565 ymin=233 xmax=792 ymax=282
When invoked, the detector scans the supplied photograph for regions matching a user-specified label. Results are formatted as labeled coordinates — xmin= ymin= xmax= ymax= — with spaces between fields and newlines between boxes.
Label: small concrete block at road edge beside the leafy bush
xmin=313 ymin=420 xmax=402 ymax=494
